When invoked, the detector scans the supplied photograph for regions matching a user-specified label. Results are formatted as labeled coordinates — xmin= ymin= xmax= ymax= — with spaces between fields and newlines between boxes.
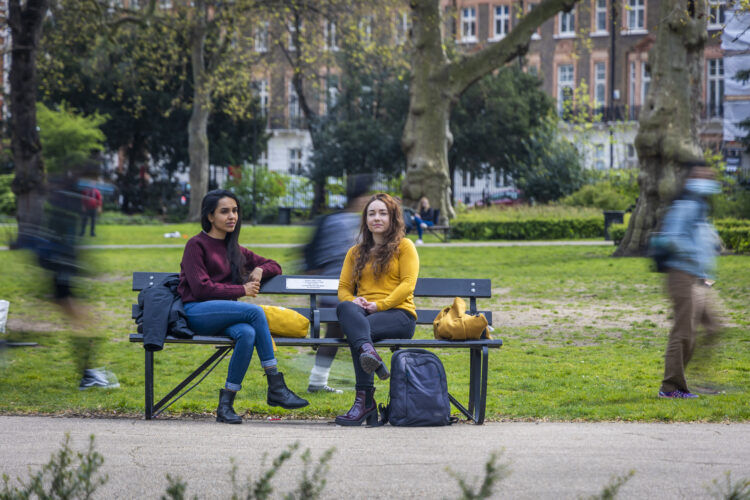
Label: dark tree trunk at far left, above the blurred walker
xmin=8 ymin=0 xmax=49 ymax=231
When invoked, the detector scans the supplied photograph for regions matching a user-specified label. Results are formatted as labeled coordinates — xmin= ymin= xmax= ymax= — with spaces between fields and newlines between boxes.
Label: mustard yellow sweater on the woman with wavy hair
xmin=339 ymin=238 xmax=419 ymax=318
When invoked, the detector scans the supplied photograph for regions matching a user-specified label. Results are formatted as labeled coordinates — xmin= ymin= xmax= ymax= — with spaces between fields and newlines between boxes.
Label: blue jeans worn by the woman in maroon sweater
xmin=185 ymin=300 xmax=277 ymax=391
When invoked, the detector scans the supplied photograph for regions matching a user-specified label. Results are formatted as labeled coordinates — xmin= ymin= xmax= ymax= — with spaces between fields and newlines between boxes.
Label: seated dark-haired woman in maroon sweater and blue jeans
xmin=178 ymin=189 xmax=308 ymax=424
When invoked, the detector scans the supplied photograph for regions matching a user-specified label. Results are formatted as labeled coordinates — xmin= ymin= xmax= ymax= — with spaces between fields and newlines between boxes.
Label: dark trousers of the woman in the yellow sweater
xmin=336 ymin=301 xmax=417 ymax=390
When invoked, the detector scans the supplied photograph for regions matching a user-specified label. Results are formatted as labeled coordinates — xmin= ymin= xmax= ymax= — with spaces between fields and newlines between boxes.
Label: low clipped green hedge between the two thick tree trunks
xmin=451 ymin=217 xmax=604 ymax=240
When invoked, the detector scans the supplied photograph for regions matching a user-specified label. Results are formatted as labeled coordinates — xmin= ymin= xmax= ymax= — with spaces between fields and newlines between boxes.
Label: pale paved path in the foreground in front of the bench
xmin=0 ymin=416 xmax=750 ymax=500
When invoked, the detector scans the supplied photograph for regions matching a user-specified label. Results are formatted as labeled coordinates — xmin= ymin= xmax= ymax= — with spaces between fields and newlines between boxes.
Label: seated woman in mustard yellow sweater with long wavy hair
xmin=336 ymin=193 xmax=419 ymax=425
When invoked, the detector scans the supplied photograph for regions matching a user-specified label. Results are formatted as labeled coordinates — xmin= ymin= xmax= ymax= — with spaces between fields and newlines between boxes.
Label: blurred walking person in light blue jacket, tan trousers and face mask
xmin=659 ymin=164 xmax=721 ymax=398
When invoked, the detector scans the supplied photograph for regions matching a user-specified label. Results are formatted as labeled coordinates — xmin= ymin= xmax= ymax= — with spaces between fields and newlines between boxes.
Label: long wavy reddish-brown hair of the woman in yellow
xmin=354 ymin=193 xmax=406 ymax=286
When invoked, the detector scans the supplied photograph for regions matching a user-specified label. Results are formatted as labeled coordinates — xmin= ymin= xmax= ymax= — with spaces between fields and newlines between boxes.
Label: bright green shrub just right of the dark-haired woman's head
xmin=225 ymin=165 xmax=290 ymax=218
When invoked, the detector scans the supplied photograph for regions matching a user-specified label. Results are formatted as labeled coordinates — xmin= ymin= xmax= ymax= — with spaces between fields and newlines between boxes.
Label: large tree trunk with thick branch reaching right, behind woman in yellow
xmin=401 ymin=0 xmax=577 ymax=224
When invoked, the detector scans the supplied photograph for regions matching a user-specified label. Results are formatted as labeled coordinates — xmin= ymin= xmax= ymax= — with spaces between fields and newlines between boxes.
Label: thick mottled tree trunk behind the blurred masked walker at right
xmin=614 ymin=0 xmax=708 ymax=257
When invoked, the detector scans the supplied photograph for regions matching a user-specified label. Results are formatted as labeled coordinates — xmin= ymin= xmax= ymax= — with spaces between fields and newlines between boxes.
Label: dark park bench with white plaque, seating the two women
xmin=130 ymin=272 xmax=503 ymax=424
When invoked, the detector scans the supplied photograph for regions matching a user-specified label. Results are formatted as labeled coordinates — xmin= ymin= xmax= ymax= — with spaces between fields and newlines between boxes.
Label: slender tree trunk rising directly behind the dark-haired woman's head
xmin=188 ymin=12 xmax=211 ymax=222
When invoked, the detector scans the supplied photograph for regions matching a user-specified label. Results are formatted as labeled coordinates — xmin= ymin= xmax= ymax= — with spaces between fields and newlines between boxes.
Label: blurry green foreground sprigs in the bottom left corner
xmin=0 ymin=434 xmax=108 ymax=500
